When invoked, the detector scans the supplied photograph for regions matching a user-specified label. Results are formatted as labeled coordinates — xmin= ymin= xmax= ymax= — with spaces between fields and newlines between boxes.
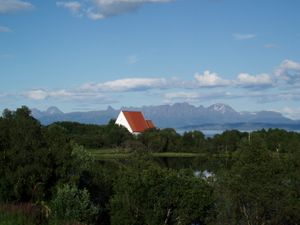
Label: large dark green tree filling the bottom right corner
xmin=216 ymin=136 xmax=300 ymax=225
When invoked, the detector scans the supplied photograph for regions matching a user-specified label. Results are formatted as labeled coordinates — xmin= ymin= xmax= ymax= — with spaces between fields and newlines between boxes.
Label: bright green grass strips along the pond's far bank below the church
xmin=88 ymin=148 xmax=201 ymax=160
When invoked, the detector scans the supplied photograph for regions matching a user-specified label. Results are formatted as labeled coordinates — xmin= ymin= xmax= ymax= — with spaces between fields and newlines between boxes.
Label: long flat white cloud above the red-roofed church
xmin=81 ymin=78 xmax=168 ymax=92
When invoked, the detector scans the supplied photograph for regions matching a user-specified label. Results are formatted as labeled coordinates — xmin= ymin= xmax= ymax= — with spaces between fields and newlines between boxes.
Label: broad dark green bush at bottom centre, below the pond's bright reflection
xmin=110 ymin=161 xmax=214 ymax=225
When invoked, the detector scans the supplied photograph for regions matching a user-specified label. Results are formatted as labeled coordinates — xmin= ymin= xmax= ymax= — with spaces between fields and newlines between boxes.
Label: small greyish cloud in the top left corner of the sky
xmin=0 ymin=0 xmax=34 ymax=13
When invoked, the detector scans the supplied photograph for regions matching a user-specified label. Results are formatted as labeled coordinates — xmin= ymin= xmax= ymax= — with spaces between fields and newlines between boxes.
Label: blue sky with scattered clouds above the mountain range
xmin=0 ymin=0 xmax=300 ymax=119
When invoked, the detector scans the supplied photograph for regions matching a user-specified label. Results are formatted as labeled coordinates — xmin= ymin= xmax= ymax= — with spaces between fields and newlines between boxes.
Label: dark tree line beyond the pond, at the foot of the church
xmin=54 ymin=120 xmax=300 ymax=154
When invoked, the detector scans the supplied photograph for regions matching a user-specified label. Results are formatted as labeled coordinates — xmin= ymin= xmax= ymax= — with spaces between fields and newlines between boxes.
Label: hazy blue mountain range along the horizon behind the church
xmin=31 ymin=103 xmax=300 ymax=130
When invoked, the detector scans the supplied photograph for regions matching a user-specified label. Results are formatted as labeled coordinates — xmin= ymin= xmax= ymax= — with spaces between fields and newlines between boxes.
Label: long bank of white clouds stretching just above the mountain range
xmin=16 ymin=60 xmax=300 ymax=117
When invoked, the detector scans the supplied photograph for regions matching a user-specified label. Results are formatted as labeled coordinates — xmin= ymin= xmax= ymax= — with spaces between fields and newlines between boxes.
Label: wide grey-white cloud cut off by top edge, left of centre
xmin=57 ymin=0 xmax=175 ymax=20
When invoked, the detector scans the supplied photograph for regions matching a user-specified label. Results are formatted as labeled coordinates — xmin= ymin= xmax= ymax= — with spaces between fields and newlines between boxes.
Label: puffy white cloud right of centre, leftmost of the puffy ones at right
xmin=195 ymin=70 xmax=232 ymax=87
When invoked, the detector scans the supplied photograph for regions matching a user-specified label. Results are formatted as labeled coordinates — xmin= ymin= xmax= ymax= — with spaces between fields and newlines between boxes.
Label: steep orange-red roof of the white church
xmin=123 ymin=111 xmax=154 ymax=132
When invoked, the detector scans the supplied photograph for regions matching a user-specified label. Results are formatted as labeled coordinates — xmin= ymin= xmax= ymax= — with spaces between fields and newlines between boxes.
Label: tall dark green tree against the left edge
xmin=0 ymin=107 xmax=48 ymax=201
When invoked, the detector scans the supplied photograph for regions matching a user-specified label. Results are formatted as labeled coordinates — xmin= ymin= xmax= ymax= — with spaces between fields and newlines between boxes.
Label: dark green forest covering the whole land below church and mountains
xmin=0 ymin=106 xmax=300 ymax=225
